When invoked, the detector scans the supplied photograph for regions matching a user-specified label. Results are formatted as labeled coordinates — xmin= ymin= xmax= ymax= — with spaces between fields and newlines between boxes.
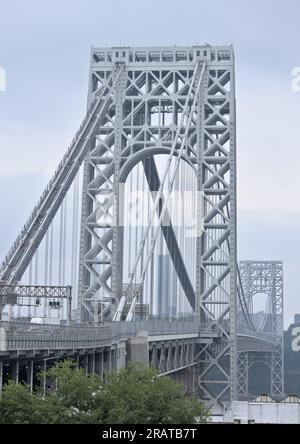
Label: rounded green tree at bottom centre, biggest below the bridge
xmin=96 ymin=365 xmax=209 ymax=424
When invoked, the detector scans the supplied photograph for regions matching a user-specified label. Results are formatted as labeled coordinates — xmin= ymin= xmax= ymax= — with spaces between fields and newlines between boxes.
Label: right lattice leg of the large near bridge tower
xmin=196 ymin=49 xmax=237 ymax=404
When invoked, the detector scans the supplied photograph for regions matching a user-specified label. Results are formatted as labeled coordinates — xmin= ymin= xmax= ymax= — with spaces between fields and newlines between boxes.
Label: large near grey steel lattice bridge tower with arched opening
xmin=78 ymin=45 xmax=237 ymax=406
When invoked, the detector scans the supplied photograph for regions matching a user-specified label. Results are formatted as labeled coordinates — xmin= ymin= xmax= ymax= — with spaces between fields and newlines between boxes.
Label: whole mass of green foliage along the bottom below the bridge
xmin=0 ymin=361 xmax=209 ymax=424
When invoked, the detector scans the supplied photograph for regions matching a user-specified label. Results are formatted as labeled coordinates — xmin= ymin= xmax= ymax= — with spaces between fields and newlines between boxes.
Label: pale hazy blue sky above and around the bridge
xmin=0 ymin=0 xmax=300 ymax=325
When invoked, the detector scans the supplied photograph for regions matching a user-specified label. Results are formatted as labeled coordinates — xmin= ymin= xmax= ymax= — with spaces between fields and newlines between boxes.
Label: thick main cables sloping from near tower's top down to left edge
xmin=0 ymin=64 xmax=123 ymax=319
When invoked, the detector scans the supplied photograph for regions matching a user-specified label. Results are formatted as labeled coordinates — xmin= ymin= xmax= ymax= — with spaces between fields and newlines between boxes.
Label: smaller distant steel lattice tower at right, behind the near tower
xmin=237 ymin=261 xmax=284 ymax=398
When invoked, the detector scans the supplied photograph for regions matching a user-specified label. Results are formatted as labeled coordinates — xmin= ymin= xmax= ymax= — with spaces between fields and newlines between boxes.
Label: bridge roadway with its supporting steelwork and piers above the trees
xmin=0 ymin=319 xmax=272 ymax=389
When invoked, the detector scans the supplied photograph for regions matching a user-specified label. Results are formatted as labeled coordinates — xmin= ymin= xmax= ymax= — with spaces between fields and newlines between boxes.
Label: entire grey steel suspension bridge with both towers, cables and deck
xmin=0 ymin=45 xmax=284 ymax=408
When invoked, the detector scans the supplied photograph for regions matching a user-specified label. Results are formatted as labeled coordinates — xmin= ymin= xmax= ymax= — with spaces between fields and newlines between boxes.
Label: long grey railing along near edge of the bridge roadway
xmin=0 ymin=320 xmax=199 ymax=352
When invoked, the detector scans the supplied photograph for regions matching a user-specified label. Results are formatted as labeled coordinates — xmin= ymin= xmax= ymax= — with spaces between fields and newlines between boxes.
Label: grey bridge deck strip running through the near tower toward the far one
xmin=0 ymin=320 xmax=272 ymax=354
